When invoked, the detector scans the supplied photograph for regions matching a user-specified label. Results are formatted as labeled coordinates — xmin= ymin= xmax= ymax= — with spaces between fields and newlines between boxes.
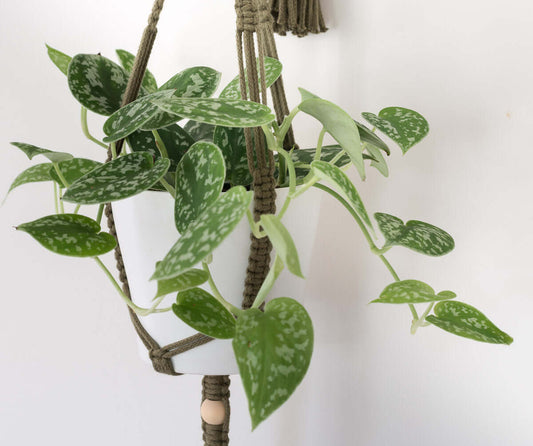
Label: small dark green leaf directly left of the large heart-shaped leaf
xmin=172 ymin=288 xmax=235 ymax=339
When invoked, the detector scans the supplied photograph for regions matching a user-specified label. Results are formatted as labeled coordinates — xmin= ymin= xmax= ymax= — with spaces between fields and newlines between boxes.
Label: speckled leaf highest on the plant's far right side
xmin=362 ymin=107 xmax=429 ymax=153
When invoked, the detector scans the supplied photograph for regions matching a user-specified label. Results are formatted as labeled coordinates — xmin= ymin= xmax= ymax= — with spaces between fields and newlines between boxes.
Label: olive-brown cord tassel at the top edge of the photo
xmin=272 ymin=0 xmax=327 ymax=37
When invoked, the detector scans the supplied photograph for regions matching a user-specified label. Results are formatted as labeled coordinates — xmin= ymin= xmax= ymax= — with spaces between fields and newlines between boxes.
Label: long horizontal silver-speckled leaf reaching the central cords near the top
xmin=153 ymin=97 xmax=276 ymax=127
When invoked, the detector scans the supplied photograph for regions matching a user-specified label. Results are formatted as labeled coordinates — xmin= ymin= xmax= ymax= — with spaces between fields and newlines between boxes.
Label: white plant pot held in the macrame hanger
xmin=113 ymin=188 xmax=322 ymax=375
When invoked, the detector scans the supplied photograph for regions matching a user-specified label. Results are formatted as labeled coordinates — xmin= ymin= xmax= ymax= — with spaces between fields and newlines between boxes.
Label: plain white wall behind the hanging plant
xmin=0 ymin=0 xmax=533 ymax=446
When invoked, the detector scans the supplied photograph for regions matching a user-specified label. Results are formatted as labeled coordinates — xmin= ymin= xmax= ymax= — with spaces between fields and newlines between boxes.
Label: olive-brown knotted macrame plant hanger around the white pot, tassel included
xmin=105 ymin=0 xmax=326 ymax=446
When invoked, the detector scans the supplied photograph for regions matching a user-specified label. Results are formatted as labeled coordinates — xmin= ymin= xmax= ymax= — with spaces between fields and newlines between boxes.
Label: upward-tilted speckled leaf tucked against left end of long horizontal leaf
xmin=104 ymin=90 xmax=174 ymax=143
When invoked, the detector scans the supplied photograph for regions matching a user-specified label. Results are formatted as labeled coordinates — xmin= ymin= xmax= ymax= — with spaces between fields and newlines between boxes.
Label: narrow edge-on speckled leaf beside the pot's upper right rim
xmin=311 ymin=161 xmax=374 ymax=230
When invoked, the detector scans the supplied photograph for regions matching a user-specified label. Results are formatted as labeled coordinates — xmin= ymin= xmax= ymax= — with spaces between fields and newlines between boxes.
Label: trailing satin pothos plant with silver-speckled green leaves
xmin=4 ymin=47 xmax=512 ymax=428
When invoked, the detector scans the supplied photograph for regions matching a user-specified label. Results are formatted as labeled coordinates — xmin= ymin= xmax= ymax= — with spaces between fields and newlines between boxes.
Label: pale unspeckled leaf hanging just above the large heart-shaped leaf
xmin=259 ymin=214 xmax=304 ymax=278
